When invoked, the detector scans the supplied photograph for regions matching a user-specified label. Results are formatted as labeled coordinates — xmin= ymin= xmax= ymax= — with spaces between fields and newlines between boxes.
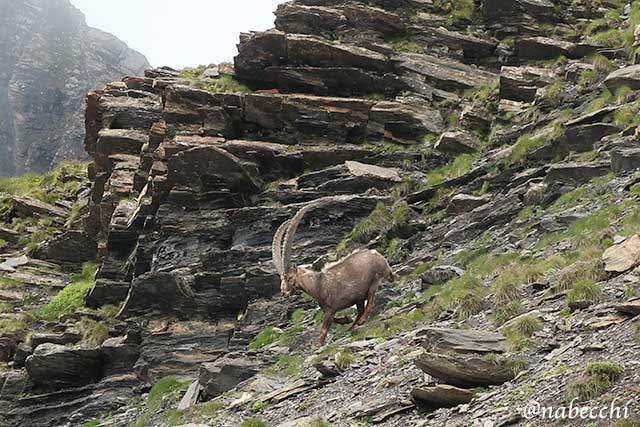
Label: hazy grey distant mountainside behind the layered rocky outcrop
xmin=0 ymin=0 xmax=149 ymax=176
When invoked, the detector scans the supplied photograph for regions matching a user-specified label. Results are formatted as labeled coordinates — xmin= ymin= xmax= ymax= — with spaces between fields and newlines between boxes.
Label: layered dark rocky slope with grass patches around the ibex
xmin=0 ymin=0 xmax=640 ymax=427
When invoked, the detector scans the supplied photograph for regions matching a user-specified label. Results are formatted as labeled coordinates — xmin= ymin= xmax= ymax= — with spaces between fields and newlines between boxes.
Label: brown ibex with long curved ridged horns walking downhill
xmin=272 ymin=198 xmax=393 ymax=346
